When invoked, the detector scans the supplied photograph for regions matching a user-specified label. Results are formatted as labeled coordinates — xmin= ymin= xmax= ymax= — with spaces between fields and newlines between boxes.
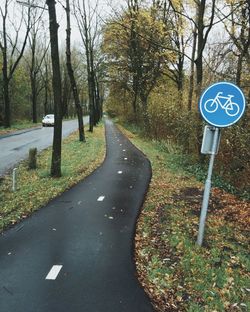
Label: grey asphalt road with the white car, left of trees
xmin=0 ymin=117 xmax=88 ymax=176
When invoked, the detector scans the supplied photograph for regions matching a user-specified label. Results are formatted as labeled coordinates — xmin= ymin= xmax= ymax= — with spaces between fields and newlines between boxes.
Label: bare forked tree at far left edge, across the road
xmin=0 ymin=0 xmax=31 ymax=128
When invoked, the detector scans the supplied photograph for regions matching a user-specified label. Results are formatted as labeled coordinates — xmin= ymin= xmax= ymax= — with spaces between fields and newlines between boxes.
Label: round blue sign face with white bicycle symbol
xmin=199 ymin=82 xmax=246 ymax=128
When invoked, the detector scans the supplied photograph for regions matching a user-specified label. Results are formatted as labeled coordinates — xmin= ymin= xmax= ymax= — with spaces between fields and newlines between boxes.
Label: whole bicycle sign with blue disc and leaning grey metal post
xmin=197 ymin=82 xmax=246 ymax=246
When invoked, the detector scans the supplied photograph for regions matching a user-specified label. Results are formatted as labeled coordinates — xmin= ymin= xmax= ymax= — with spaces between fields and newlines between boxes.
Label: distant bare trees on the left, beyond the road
xmin=0 ymin=0 xmax=104 ymax=130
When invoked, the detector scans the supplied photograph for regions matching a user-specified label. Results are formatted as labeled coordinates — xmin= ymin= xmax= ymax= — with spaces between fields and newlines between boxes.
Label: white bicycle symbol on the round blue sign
xmin=204 ymin=92 xmax=240 ymax=117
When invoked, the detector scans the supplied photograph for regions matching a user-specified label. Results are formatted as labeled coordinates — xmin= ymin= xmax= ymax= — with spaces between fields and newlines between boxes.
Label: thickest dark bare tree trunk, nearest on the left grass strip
xmin=46 ymin=0 xmax=62 ymax=177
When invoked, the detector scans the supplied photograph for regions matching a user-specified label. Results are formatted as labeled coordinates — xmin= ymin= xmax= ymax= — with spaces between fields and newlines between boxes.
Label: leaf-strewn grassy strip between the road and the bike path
xmin=0 ymin=125 xmax=105 ymax=232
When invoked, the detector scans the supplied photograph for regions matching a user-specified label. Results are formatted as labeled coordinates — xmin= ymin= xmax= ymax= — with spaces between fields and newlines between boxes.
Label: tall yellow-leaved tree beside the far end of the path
xmin=103 ymin=0 xmax=173 ymax=132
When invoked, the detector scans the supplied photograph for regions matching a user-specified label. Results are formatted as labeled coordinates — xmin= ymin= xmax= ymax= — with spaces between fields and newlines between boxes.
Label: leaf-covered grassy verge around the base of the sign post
xmin=119 ymin=125 xmax=250 ymax=312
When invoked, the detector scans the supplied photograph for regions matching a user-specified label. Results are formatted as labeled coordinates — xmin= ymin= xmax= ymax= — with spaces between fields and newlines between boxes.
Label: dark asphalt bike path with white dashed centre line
xmin=0 ymin=121 xmax=153 ymax=312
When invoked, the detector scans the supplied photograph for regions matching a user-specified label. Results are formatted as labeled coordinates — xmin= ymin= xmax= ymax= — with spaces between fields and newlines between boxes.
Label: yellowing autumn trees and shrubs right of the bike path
xmin=103 ymin=0 xmax=250 ymax=198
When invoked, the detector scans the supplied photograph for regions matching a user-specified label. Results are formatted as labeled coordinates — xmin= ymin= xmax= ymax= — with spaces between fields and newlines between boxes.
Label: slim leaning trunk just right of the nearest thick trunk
xmin=66 ymin=0 xmax=85 ymax=142
